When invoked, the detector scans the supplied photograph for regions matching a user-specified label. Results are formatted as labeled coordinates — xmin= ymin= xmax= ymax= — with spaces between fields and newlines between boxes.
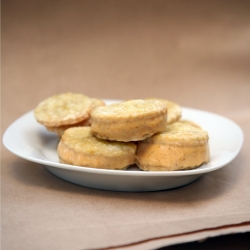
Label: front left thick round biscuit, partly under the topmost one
xmin=57 ymin=127 xmax=136 ymax=169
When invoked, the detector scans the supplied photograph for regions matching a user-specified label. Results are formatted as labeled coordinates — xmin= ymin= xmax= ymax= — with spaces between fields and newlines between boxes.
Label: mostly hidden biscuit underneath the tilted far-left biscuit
xmin=46 ymin=98 xmax=105 ymax=137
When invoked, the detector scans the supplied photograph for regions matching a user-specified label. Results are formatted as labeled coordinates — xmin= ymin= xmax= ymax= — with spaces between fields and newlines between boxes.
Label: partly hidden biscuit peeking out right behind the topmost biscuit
xmin=146 ymin=98 xmax=182 ymax=124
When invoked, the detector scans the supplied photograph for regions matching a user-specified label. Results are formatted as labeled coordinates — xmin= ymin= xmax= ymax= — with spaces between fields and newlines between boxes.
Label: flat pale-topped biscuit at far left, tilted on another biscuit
xmin=34 ymin=92 xmax=92 ymax=127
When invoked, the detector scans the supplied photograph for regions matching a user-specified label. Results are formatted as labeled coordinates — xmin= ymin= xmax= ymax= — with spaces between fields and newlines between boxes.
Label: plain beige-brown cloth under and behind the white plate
xmin=1 ymin=0 xmax=250 ymax=250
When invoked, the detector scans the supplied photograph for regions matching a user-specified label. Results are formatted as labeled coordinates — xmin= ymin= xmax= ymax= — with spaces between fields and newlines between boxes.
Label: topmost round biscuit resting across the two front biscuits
xmin=91 ymin=99 xmax=167 ymax=142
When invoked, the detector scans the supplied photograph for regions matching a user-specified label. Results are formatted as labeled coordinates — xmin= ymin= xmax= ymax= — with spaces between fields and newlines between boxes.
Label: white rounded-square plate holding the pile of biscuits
xmin=3 ymin=100 xmax=244 ymax=192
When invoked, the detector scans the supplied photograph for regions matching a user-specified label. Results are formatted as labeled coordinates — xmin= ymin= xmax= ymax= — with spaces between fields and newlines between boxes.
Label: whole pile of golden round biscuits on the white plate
xmin=34 ymin=93 xmax=209 ymax=171
